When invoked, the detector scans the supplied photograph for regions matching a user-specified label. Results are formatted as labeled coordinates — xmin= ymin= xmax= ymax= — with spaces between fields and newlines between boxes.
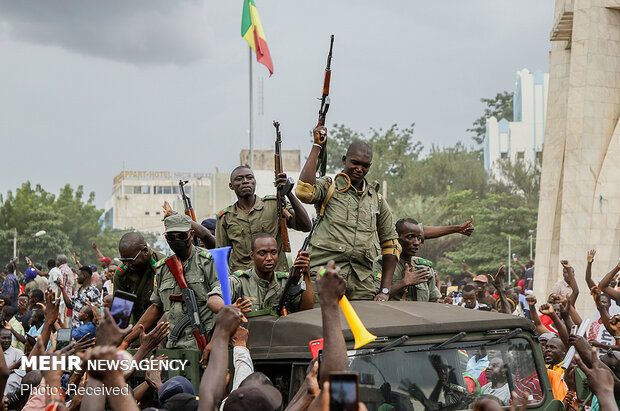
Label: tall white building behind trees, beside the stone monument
xmin=484 ymin=69 xmax=549 ymax=178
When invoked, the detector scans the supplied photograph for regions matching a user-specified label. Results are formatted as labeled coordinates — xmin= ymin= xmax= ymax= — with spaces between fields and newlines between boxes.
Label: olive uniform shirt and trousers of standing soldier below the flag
xmin=215 ymin=196 xmax=297 ymax=272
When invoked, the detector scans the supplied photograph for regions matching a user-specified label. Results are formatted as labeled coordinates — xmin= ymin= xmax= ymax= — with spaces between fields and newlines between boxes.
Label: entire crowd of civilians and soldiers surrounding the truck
xmin=0 ymin=127 xmax=620 ymax=411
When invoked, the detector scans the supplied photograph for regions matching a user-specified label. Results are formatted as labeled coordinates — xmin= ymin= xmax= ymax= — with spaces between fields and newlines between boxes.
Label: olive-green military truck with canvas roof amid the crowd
xmin=248 ymin=301 xmax=576 ymax=411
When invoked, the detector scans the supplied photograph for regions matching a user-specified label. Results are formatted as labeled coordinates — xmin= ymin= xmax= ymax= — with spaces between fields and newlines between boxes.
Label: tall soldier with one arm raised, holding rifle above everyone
xmin=296 ymin=126 xmax=397 ymax=301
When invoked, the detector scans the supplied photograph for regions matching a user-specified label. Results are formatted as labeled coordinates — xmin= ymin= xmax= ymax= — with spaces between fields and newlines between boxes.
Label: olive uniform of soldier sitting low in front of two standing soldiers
xmin=209 ymin=268 xmax=303 ymax=316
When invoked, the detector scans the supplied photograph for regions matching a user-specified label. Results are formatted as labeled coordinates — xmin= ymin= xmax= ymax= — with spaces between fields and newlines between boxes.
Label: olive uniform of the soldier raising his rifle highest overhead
xmin=296 ymin=175 xmax=398 ymax=300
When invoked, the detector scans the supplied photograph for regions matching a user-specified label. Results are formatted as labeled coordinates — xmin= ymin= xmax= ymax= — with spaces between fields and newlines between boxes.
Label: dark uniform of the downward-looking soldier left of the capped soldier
xmin=114 ymin=250 xmax=163 ymax=324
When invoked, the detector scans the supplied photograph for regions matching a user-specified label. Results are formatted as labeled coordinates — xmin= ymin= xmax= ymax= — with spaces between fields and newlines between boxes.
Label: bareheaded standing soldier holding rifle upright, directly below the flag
xmin=215 ymin=166 xmax=312 ymax=272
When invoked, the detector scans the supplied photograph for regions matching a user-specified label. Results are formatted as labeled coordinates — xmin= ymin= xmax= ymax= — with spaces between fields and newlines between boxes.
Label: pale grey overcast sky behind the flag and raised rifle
xmin=0 ymin=0 xmax=554 ymax=207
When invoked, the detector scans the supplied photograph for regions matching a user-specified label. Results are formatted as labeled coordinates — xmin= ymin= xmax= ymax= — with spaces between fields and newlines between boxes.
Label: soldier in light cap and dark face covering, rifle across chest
xmin=125 ymin=214 xmax=219 ymax=349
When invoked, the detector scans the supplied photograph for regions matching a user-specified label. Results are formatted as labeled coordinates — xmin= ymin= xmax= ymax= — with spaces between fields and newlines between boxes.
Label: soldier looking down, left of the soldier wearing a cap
xmin=114 ymin=233 xmax=163 ymax=324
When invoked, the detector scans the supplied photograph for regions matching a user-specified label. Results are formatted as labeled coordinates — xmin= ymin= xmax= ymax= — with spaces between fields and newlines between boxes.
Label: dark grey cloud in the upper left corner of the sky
xmin=0 ymin=0 xmax=213 ymax=66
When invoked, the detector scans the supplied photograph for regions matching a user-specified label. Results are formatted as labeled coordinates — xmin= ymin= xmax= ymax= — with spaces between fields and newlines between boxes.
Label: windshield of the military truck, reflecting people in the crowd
xmin=349 ymin=338 xmax=544 ymax=411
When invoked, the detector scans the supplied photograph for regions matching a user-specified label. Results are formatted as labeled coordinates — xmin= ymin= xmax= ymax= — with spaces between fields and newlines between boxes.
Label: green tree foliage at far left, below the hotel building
xmin=0 ymin=182 xmax=155 ymax=268
